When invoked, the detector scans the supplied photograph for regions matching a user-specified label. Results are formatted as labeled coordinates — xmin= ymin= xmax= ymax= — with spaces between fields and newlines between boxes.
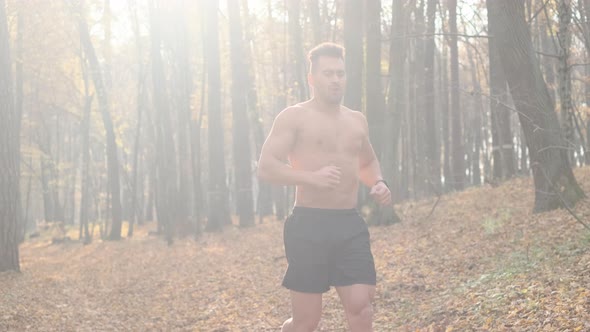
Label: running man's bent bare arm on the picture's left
xmin=257 ymin=108 xmax=310 ymax=185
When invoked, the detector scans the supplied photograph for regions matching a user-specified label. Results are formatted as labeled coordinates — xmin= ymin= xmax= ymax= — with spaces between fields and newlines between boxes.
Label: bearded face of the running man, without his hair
xmin=308 ymin=56 xmax=346 ymax=104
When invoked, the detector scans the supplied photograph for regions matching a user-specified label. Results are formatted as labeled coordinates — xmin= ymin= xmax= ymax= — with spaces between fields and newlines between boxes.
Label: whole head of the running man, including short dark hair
xmin=307 ymin=43 xmax=346 ymax=104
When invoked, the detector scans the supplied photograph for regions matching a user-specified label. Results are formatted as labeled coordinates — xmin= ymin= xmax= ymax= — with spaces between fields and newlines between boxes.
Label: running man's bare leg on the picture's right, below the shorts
xmin=336 ymin=284 xmax=375 ymax=332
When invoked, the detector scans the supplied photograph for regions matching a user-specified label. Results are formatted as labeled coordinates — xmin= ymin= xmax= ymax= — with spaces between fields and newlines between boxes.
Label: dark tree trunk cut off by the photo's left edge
xmin=0 ymin=0 xmax=20 ymax=272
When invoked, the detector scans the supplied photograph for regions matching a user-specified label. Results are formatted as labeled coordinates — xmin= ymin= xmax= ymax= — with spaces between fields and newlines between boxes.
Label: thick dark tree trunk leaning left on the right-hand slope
xmin=486 ymin=0 xmax=585 ymax=212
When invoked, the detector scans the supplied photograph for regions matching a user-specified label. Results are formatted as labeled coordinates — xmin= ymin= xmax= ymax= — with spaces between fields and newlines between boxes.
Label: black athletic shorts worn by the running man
xmin=283 ymin=207 xmax=376 ymax=293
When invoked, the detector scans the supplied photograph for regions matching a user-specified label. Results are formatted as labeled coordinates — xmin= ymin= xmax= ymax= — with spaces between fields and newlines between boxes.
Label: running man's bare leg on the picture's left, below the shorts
xmin=281 ymin=291 xmax=322 ymax=332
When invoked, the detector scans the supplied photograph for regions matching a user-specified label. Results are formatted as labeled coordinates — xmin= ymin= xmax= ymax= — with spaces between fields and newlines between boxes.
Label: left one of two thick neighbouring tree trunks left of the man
xmin=205 ymin=0 xmax=231 ymax=231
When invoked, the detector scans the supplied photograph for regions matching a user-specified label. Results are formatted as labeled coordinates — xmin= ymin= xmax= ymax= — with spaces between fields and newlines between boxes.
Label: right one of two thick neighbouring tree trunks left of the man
xmin=227 ymin=0 xmax=254 ymax=227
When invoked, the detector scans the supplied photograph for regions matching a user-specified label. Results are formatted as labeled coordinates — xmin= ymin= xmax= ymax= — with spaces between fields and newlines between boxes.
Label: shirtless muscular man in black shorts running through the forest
xmin=258 ymin=43 xmax=391 ymax=332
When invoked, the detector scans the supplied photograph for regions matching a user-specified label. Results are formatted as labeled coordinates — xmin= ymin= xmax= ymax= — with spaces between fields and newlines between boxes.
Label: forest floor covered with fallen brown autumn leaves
xmin=0 ymin=168 xmax=590 ymax=332
